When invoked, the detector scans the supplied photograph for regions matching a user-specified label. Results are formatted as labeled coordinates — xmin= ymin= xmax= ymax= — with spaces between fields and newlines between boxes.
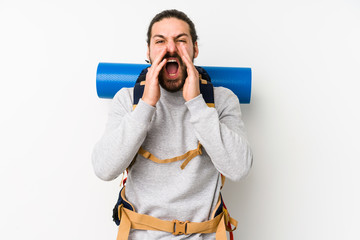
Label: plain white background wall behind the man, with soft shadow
xmin=0 ymin=0 xmax=360 ymax=240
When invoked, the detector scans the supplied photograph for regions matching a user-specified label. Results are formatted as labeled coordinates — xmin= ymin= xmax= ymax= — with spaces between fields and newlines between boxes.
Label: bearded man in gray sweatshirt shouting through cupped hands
xmin=92 ymin=10 xmax=252 ymax=239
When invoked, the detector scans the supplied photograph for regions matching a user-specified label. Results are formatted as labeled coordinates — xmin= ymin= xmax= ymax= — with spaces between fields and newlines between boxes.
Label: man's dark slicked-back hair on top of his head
xmin=147 ymin=9 xmax=198 ymax=45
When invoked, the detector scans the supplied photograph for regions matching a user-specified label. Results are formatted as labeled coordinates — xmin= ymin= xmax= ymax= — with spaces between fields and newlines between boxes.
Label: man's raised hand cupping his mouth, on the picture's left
xmin=142 ymin=48 xmax=167 ymax=107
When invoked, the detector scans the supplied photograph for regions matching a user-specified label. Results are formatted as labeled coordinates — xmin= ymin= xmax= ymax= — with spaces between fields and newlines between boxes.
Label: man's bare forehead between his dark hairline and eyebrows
xmin=151 ymin=18 xmax=190 ymax=38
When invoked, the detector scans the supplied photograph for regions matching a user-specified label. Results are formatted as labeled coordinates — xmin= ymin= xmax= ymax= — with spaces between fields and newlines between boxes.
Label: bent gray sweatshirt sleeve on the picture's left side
xmin=92 ymin=88 xmax=155 ymax=181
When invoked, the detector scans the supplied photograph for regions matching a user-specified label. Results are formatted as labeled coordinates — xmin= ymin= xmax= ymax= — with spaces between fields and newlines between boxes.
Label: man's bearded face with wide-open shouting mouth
xmin=147 ymin=18 xmax=199 ymax=92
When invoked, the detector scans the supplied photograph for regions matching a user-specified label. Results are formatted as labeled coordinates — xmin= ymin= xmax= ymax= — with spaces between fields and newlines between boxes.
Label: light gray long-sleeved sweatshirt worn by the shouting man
xmin=92 ymin=87 xmax=252 ymax=240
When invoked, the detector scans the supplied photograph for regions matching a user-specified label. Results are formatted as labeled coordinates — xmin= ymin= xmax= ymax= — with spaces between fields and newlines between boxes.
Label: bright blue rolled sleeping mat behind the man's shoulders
xmin=96 ymin=62 xmax=251 ymax=103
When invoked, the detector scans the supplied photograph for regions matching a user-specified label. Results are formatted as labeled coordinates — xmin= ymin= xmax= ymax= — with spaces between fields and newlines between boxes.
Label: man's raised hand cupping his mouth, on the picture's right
xmin=179 ymin=45 xmax=200 ymax=101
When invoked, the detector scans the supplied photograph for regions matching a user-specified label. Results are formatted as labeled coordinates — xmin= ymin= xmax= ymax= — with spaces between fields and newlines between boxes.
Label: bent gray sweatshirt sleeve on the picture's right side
xmin=185 ymin=87 xmax=253 ymax=181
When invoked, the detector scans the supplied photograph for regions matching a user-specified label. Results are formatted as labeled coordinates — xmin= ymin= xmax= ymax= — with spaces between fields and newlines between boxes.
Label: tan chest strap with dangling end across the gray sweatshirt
xmin=138 ymin=142 xmax=202 ymax=169
